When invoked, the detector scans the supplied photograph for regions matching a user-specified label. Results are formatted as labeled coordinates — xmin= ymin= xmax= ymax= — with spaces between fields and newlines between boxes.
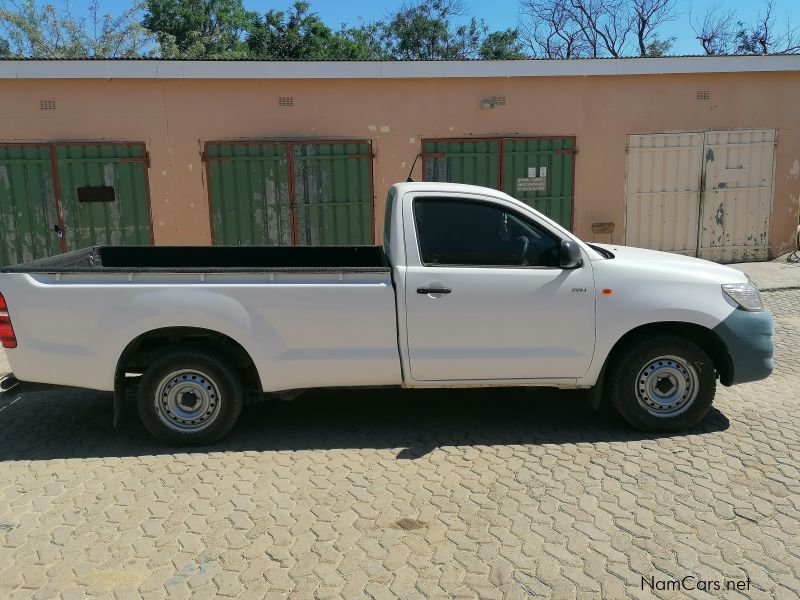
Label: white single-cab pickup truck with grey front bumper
xmin=0 ymin=183 xmax=772 ymax=444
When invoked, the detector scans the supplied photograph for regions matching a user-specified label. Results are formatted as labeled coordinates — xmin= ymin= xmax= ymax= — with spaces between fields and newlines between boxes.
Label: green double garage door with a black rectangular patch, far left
xmin=0 ymin=142 xmax=152 ymax=264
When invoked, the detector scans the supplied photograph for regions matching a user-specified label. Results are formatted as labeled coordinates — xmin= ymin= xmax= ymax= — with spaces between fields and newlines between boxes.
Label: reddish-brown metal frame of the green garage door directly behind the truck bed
xmin=200 ymin=138 xmax=375 ymax=246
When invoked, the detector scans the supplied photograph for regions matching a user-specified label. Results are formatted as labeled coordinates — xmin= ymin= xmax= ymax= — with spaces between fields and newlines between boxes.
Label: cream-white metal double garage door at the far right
xmin=625 ymin=129 xmax=776 ymax=262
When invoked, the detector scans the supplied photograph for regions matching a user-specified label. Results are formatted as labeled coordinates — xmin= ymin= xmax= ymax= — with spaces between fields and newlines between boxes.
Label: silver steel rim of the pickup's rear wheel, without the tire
xmin=154 ymin=369 xmax=222 ymax=433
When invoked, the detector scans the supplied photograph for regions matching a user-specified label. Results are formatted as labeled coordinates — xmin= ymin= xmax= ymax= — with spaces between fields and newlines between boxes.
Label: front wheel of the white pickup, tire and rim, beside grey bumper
xmin=606 ymin=335 xmax=717 ymax=432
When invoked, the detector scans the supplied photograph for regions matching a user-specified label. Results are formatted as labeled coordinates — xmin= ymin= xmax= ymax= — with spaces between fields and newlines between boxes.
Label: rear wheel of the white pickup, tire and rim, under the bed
xmin=137 ymin=348 xmax=244 ymax=446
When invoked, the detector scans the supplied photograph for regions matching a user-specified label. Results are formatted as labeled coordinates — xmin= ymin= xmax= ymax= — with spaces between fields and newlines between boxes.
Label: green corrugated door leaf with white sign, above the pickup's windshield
xmin=501 ymin=138 xmax=575 ymax=229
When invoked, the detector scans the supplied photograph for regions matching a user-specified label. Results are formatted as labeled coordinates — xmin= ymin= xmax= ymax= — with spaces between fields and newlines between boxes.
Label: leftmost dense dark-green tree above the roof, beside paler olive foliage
xmin=142 ymin=0 xmax=254 ymax=58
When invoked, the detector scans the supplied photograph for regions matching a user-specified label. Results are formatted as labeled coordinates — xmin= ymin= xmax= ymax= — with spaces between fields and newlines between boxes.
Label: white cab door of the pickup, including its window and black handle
xmin=404 ymin=195 xmax=595 ymax=381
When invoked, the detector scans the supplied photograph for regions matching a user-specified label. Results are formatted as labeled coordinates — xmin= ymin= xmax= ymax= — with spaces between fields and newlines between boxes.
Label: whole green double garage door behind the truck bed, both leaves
xmin=205 ymin=141 xmax=374 ymax=246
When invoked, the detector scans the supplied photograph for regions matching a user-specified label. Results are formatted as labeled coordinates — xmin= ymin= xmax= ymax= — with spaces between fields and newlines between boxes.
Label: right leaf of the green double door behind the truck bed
xmin=291 ymin=142 xmax=373 ymax=246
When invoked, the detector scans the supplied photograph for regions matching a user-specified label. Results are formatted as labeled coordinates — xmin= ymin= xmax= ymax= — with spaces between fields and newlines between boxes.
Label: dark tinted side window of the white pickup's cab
xmin=414 ymin=198 xmax=559 ymax=267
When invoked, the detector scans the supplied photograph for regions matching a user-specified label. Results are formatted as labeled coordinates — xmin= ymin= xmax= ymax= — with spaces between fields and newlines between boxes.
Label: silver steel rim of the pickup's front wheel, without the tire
xmin=635 ymin=356 xmax=699 ymax=417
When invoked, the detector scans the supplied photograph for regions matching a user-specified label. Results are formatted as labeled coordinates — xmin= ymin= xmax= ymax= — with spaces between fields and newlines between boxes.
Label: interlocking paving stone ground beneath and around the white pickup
xmin=0 ymin=290 xmax=800 ymax=599
